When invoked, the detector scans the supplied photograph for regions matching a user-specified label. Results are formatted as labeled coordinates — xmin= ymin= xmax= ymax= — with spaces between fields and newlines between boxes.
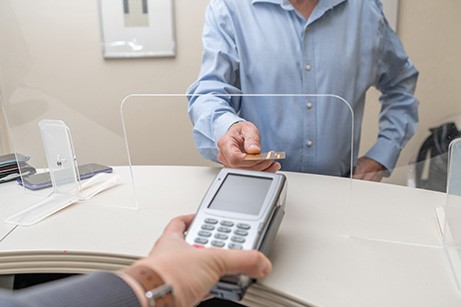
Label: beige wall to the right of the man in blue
xmin=361 ymin=0 xmax=461 ymax=184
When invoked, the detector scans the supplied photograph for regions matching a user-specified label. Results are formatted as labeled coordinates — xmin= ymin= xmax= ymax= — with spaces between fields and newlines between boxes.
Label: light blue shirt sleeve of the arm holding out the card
xmin=187 ymin=1 xmax=243 ymax=161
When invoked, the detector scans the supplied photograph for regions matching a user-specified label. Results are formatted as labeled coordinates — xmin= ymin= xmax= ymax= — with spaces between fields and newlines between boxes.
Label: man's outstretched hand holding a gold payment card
xmin=218 ymin=122 xmax=281 ymax=173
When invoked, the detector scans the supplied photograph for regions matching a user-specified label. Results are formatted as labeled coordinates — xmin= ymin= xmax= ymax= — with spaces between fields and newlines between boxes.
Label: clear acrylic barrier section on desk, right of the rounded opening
xmin=350 ymin=122 xmax=446 ymax=248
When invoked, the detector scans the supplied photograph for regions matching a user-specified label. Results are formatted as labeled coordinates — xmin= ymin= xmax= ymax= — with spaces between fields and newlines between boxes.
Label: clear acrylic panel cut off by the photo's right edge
xmin=440 ymin=139 xmax=461 ymax=290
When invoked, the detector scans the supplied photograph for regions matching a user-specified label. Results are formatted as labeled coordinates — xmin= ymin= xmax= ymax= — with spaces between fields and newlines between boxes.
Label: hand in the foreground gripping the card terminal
xmin=134 ymin=215 xmax=272 ymax=307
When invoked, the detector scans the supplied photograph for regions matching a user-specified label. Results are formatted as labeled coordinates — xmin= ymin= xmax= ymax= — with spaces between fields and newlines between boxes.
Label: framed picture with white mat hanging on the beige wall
xmin=99 ymin=0 xmax=176 ymax=59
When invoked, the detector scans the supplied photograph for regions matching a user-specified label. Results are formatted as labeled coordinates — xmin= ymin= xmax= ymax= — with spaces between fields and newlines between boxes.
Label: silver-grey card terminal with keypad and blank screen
xmin=186 ymin=168 xmax=287 ymax=300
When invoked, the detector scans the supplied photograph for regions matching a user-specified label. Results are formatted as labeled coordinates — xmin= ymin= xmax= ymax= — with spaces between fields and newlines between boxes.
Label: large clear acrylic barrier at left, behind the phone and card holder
xmin=0 ymin=7 xmax=136 ymax=220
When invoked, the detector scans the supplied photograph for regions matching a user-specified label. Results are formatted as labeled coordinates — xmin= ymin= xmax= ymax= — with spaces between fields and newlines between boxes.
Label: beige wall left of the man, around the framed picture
xmin=0 ymin=0 xmax=207 ymax=166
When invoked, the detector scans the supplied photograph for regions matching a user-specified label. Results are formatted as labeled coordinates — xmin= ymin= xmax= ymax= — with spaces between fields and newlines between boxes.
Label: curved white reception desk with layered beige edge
xmin=0 ymin=166 xmax=461 ymax=307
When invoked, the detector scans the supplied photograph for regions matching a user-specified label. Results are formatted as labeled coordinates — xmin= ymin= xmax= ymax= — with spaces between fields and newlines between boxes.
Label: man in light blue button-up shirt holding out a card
xmin=188 ymin=0 xmax=418 ymax=181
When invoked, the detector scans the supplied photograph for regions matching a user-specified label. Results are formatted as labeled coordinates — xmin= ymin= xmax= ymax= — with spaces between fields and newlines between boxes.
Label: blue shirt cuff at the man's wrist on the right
xmin=365 ymin=138 xmax=401 ymax=175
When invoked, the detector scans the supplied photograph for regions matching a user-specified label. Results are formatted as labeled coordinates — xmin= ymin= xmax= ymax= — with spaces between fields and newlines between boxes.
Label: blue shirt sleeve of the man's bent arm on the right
xmin=365 ymin=6 xmax=419 ymax=171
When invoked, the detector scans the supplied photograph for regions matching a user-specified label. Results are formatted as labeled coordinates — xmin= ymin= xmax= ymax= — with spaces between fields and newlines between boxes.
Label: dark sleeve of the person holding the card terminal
xmin=0 ymin=272 xmax=140 ymax=307
